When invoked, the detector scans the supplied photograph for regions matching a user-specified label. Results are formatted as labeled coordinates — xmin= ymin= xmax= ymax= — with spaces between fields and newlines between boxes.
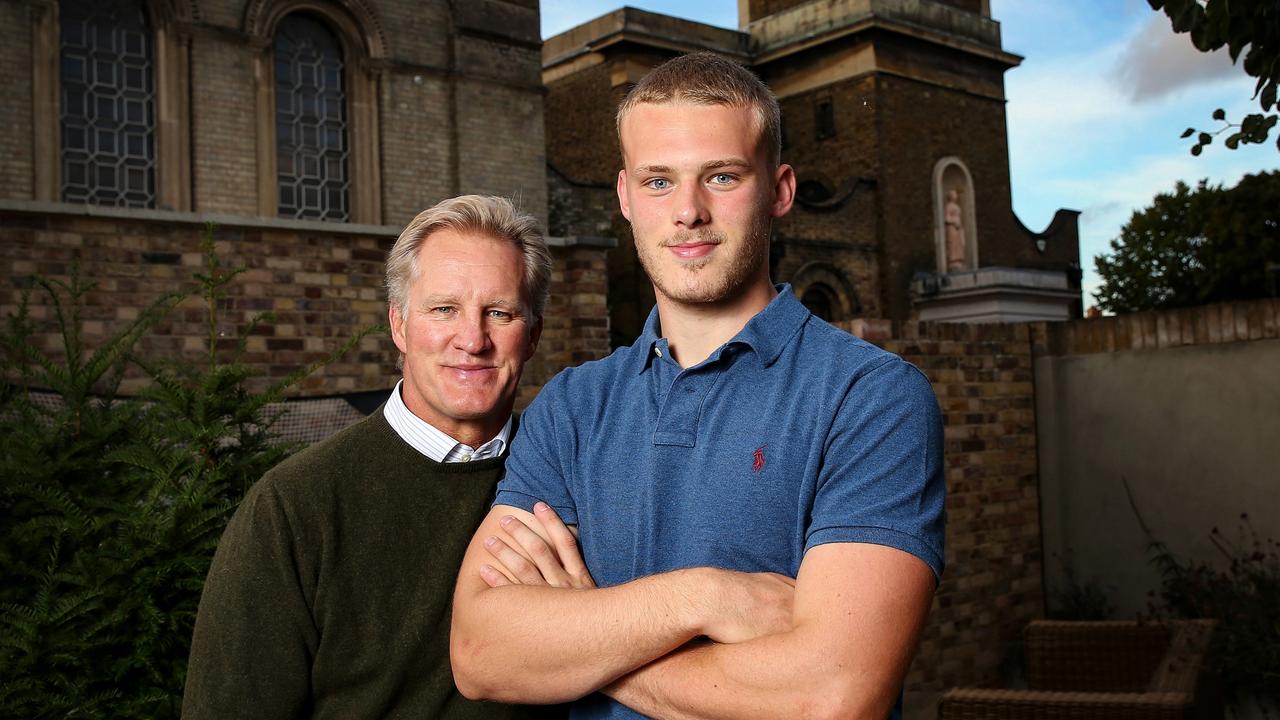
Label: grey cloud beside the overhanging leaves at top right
xmin=1111 ymin=13 xmax=1244 ymax=101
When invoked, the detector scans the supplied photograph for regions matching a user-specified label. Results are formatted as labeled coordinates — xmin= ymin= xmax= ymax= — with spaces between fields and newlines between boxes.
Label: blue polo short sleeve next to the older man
xmin=494 ymin=373 xmax=577 ymax=525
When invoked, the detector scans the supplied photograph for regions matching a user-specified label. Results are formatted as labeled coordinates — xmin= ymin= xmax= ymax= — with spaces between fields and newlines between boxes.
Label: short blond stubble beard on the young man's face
xmin=631 ymin=215 xmax=772 ymax=305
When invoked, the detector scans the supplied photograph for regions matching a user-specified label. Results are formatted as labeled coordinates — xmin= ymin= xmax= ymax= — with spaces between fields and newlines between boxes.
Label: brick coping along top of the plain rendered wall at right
xmin=1032 ymin=299 xmax=1280 ymax=356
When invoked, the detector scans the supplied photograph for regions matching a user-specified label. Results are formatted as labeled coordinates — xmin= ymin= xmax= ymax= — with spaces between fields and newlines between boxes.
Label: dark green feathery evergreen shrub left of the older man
xmin=0 ymin=228 xmax=376 ymax=719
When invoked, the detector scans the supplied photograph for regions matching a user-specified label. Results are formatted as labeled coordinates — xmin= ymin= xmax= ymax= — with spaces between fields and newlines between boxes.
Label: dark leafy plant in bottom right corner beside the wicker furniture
xmin=1151 ymin=515 xmax=1280 ymax=710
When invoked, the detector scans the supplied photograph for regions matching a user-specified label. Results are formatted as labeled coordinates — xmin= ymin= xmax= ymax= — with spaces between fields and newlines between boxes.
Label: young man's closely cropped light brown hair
xmin=617 ymin=51 xmax=782 ymax=167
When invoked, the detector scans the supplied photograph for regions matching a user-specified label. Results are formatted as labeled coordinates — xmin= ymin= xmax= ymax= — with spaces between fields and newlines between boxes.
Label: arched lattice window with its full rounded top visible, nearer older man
xmin=273 ymin=13 xmax=351 ymax=222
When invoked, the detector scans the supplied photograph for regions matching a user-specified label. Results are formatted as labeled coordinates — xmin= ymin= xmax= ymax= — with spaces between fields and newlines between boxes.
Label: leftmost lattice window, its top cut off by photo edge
xmin=59 ymin=0 xmax=156 ymax=208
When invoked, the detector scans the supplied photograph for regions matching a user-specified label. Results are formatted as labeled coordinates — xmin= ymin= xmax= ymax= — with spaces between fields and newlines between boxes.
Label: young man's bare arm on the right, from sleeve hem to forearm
xmin=604 ymin=544 xmax=933 ymax=720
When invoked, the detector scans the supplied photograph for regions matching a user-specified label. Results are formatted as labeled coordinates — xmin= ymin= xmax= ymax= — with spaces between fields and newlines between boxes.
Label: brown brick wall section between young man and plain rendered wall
xmin=840 ymin=320 xmax=1043 ymax=696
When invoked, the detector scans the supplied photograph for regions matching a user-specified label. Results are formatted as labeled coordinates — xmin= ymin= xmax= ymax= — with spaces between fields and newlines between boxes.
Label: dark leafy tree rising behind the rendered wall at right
xmin=1093 ymin=172 xmax=1280 ymax=313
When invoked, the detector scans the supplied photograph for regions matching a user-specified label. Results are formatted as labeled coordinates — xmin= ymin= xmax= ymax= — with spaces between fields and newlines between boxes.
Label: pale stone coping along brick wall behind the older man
xmin=0 ymin=200 xmax=618 ymax=249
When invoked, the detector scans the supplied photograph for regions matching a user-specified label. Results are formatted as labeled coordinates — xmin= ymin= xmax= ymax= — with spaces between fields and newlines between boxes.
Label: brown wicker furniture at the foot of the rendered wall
xmin=938 ymin=620 xmax=1222 ymax=720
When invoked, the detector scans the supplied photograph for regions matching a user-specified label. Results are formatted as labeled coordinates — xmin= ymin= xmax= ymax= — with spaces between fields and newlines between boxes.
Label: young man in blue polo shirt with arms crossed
xmin=451 ymin=54 xmax=943 ymax=719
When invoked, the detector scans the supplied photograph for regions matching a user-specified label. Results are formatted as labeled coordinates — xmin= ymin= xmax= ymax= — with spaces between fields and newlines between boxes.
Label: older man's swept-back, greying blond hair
xmin=385 ymin=195 xmax=552 ymax=319
